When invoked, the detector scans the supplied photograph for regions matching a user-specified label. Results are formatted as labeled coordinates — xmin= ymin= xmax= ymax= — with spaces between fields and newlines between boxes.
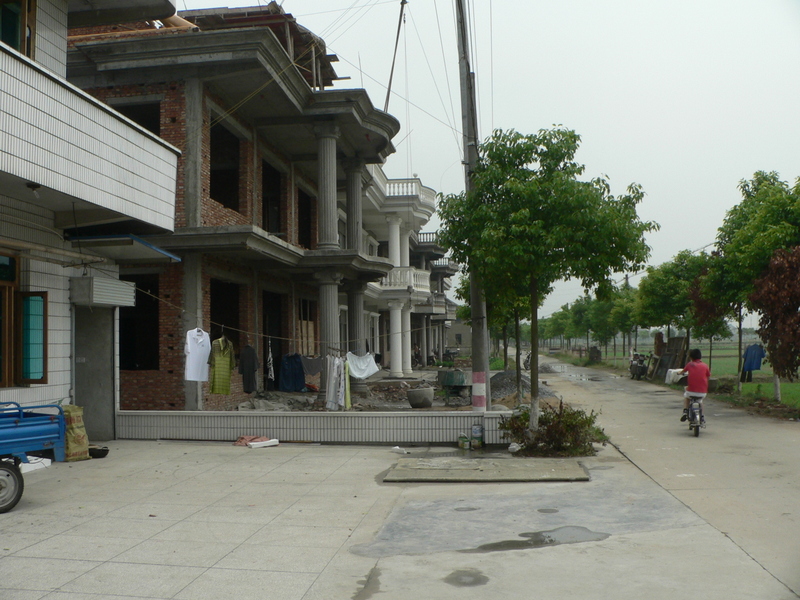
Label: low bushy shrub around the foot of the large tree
xmin=499 ymin=401 xmax=608 ymax=456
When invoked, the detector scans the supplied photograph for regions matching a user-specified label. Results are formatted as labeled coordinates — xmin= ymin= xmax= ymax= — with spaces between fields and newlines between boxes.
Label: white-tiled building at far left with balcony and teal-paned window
xmin=0 ymin=0 xmax=179 ymax=439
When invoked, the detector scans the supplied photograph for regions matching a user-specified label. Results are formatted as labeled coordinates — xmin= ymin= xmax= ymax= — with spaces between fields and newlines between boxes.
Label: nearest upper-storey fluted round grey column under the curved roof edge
xmin=314 ymin=123 xmax=340 ymax=250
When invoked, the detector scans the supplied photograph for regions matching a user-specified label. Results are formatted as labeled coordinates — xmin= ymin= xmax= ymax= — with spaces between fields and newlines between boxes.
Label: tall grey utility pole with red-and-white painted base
xmin=456 ymin=0 xmax=492 ymax=412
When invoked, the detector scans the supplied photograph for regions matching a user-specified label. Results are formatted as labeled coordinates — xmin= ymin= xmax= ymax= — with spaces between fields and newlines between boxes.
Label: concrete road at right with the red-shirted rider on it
xmin=542 ymin=358 xmax=800 ymax=598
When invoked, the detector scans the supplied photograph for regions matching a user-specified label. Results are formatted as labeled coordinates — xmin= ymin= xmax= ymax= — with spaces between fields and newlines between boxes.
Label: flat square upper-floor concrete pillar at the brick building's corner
xmin=182 ymin=79 xmax=203 ymax=227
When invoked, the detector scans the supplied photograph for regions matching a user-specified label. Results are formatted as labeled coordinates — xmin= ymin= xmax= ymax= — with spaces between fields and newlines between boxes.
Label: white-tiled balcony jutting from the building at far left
xmin=0 ymin=44 xmax=179 ymax=233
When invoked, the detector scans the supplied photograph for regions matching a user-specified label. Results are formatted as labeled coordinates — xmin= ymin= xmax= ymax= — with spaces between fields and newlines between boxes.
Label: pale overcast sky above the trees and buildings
xmin=181 ymin=0 xmax=800 ymax=324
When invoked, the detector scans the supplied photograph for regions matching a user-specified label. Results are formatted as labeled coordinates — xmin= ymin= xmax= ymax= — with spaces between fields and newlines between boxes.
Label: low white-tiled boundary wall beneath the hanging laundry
xmin=117 ymin=411 xmax=510 ymax=444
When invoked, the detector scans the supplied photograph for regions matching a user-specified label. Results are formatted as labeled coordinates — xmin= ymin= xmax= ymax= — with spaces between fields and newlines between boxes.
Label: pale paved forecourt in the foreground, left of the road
xmin=0 ymin=441 xmax=797 ymax=600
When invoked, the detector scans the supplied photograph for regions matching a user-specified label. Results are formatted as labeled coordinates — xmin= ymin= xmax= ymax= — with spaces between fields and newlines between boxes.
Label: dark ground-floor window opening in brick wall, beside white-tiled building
xmin=119 ymin=274 xmax=159 ymax=371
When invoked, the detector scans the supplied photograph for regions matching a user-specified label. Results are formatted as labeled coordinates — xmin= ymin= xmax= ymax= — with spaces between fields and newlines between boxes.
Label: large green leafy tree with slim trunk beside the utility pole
xmin=439 ymin=127 xmax=657 ymax=432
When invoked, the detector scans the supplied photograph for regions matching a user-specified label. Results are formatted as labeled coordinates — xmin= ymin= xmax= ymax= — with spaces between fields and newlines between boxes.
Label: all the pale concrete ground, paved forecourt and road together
xmin=0 ymin=360 xmax=800 ymax=600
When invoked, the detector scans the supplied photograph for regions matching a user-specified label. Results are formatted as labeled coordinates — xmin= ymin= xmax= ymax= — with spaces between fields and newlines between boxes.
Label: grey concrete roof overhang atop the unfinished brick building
xmin=68 ymin=28 xmax=400 ymax=181
